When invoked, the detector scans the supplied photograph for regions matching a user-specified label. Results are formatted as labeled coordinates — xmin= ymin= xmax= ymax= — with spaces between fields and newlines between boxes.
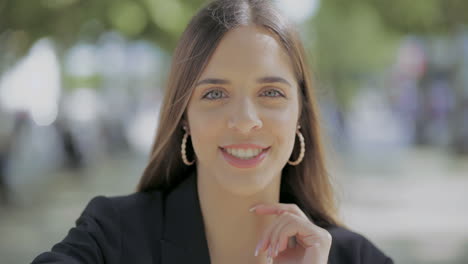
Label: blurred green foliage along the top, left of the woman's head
xmin=0 ymin=0 xmax=205 ymax=52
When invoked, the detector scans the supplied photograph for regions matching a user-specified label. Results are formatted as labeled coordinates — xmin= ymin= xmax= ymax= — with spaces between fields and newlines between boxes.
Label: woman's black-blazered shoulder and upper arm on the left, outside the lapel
xmin=33 ymin=191 xmax=166 ymax=263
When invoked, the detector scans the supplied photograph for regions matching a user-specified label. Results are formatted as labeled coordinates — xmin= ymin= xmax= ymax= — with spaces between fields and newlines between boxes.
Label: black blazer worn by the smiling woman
xmin=32 ymin=171 xmax=393 ymax=264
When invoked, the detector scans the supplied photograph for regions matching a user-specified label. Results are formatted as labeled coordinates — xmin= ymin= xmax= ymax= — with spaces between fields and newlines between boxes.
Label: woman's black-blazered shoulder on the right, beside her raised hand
xmin=327 ymin=226 xmax=393 ymax=264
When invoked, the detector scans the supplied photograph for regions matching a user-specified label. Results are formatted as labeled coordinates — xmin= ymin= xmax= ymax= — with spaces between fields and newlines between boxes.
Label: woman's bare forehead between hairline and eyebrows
xmin=202 ymin=26 xmax=293 ymax=77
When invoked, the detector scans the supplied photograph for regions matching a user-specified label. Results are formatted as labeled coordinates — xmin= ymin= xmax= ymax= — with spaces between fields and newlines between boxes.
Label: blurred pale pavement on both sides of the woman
xmin=0 ymin=149 xmax=468 ymax=264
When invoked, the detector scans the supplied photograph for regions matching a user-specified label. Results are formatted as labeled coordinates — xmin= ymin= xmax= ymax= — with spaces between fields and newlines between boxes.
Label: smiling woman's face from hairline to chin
xmin=187 ymin=26 xmax=299 ymax=195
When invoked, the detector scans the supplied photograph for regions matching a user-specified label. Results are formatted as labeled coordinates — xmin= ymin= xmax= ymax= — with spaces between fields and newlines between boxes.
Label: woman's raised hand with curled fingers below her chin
xmin=250 ymin=203 xmax=332 ymax=264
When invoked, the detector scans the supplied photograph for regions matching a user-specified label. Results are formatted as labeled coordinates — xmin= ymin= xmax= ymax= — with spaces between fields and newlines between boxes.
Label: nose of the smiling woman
xmin=228 ymin=99 xmax=263 ymax=134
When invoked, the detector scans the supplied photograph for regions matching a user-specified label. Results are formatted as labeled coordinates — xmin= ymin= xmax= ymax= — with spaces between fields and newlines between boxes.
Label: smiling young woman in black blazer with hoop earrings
xmin=33 ymin=0 xmax=393 ymax=264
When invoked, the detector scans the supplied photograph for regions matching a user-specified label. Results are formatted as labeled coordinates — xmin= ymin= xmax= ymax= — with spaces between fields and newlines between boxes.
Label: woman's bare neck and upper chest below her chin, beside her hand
xmin=197 ymin=167 xmax=281 ymax=263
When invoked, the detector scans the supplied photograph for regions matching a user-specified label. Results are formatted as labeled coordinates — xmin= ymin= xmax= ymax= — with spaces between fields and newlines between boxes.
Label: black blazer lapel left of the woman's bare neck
xmin=161 ymin=172 xmax=210 ymax=264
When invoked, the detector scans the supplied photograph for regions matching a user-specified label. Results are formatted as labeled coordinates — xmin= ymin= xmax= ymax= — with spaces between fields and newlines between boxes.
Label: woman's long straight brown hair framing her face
xmin=137 ymin=0 xmax=342 ymax=227
